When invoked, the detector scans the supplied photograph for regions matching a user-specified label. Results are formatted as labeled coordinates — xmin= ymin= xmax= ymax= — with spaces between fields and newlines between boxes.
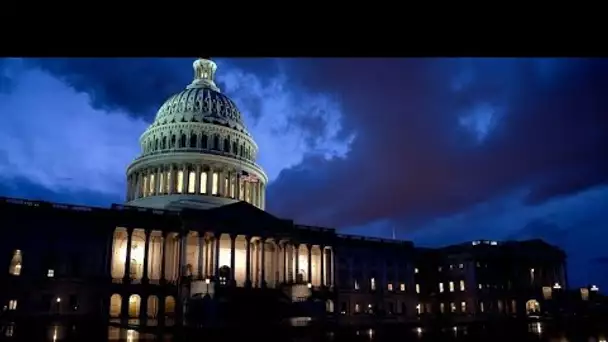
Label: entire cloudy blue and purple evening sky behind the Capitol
xmin=0 ymin=58 xmax=608 ymax=289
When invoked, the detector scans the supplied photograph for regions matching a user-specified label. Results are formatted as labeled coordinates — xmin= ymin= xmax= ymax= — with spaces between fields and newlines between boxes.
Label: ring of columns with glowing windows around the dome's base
xmin=127 ymin=164 xmax=266 ymax=209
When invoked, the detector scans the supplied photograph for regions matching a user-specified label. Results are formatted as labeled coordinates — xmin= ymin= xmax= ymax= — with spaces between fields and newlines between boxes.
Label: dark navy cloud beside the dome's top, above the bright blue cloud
xmin=27 ymin=58 xmax=284 ymax=119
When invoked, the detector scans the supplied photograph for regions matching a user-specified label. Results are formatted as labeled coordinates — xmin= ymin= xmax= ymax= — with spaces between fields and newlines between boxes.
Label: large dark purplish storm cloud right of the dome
xmin=268 ymin=59 xmax=608 ymax=230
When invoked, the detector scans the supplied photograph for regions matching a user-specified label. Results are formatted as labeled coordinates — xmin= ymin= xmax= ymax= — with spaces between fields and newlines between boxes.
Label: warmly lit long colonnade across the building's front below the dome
xmin=111 ymin=228 xmax=335 ymax=287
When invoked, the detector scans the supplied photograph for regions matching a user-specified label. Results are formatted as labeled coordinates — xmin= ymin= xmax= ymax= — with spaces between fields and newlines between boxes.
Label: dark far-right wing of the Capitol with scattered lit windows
xmin=415 ymin=240 xmax=567 ymax=318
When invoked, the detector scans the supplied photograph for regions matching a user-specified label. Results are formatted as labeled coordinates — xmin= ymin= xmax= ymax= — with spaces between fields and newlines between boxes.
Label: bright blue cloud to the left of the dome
xmin=0 ymin=60 xmax=146 ymax=197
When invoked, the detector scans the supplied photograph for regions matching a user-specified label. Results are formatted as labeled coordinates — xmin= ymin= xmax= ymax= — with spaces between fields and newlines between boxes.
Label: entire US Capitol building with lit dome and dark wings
xmin=0 ymin=59 xmax=567 ymax=325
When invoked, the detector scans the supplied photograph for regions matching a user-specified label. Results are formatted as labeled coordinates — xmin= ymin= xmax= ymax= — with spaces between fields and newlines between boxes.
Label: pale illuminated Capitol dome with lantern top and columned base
xmin=127 ymin=59 xmax=268 ymax=209
